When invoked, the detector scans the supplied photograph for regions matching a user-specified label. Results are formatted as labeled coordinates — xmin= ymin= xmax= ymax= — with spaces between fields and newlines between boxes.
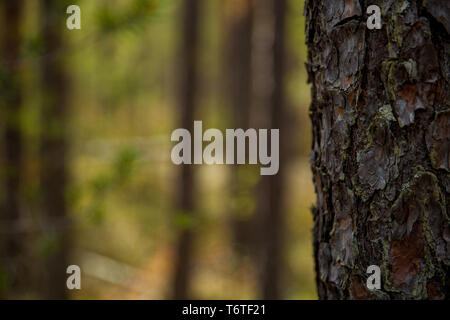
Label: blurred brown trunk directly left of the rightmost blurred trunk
xmin=224 ymin=0 xmax=257 ymax=255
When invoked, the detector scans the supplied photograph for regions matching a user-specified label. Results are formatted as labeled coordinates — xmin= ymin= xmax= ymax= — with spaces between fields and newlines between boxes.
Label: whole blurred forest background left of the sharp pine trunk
xmin=0 ymin=0 xmax=316 ymax=299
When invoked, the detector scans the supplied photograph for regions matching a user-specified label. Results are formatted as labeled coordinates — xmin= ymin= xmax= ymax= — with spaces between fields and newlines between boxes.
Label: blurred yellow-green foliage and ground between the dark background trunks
xmin=14 ymin=0 xmax=316 ymax=299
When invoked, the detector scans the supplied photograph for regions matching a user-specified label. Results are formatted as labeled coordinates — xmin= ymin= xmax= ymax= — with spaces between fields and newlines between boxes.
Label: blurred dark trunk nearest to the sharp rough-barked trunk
xmin=261 ymin=0 xmax=287 ymax=299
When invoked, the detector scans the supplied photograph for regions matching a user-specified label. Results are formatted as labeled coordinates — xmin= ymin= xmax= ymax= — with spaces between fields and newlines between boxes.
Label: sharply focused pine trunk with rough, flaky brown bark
xmin=305 ymin=0 xmax=450 ymax=299
